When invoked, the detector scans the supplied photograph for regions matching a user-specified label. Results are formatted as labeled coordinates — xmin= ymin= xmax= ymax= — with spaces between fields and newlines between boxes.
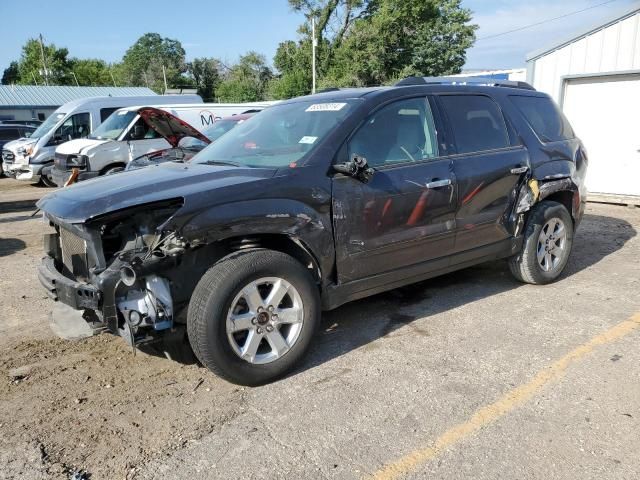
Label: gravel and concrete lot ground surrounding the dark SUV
xmin=0 ymin=179 xmax=640 ymax=480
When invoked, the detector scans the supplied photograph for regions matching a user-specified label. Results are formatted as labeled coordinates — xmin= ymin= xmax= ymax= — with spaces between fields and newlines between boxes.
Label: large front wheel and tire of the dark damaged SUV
xmin=187 ymin=249 xmax=320 ymax=386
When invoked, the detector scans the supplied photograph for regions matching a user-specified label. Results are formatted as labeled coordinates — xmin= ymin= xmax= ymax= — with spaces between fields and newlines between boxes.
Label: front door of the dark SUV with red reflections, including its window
xmin=333 ymin=97 xmax=457 ymax=283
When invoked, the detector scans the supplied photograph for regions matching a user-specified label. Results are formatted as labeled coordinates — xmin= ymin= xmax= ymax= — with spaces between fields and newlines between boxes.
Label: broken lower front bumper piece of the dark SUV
xmin=38 ymin=256 xmax=102 ymax=310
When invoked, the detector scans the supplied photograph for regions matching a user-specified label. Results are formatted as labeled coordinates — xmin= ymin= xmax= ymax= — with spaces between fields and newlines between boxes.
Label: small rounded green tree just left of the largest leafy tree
xmin=216 ymin=52 xmax=273 ymax=102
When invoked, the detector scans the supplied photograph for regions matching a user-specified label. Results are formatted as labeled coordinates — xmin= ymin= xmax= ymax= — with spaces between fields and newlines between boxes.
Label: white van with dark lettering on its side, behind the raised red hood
xmin=51 ymin=102 xmax=277 ymax=187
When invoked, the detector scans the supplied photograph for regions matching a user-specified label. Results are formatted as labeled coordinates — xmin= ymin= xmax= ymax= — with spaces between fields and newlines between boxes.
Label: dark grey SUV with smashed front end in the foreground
xmin=38 ymin=78 xmax=587 ymax=385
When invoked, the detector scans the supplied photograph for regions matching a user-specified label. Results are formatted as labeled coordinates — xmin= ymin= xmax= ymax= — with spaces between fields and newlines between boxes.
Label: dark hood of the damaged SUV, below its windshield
xmin=37 ymin=159 xmax=277 ymax=223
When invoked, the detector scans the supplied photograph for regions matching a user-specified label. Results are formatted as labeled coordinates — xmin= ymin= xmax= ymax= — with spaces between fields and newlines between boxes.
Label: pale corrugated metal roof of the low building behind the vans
xmin=0 ymin=85 xmax=156 ymax=107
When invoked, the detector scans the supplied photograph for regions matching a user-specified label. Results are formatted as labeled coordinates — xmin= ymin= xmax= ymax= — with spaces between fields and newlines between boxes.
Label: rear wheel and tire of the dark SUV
xmin=509 ymin=200 xmax=574 ymax=285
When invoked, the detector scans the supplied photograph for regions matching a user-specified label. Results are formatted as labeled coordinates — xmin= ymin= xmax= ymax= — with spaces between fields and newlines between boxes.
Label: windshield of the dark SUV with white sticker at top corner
xmin=192 ymin=100 xmax=354 ymax=168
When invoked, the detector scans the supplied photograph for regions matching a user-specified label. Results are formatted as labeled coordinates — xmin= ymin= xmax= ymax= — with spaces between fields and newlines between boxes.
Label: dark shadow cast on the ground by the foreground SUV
xmin=291 ymin=215 xmax=637 ymax=375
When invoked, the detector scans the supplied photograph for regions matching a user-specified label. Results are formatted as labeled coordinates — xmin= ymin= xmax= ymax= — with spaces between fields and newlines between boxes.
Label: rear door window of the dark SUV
xmin=440 ymin=95 xmax=510 ymax=153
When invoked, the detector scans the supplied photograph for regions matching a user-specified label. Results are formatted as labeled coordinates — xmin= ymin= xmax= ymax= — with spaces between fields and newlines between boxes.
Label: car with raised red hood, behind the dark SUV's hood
xmin=125 ymin=111 xmax=254 ymax=171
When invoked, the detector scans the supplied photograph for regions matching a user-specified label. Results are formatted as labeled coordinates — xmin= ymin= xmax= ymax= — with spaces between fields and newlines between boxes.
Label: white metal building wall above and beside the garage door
xmin=527 ymin=11 xmax=640 ymax=103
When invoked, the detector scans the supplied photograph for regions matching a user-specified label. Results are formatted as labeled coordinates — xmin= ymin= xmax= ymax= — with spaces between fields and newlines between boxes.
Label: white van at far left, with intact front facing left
xmin=2 ymin=95 xmax=202 ymax=186
